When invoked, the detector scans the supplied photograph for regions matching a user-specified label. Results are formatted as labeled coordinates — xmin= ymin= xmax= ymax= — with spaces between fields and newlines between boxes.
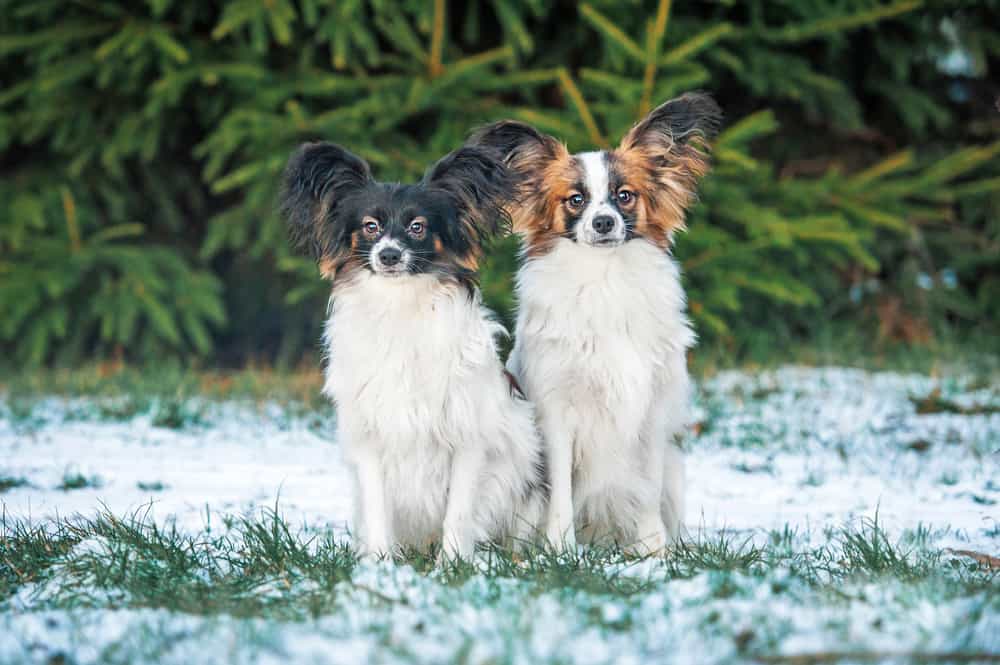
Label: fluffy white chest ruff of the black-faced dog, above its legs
xmin=324 ymin=275 xmax=502 ymax=447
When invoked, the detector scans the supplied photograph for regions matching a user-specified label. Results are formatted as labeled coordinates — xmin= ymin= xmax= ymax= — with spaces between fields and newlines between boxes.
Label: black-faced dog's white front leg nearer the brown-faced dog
xmin=441 ymin=444 xmax=483 ymax=559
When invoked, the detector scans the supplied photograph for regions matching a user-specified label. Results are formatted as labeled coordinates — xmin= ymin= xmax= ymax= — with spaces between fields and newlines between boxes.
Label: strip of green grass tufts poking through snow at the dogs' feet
xmin=0 ymin=511 xmax=1000 ymax=620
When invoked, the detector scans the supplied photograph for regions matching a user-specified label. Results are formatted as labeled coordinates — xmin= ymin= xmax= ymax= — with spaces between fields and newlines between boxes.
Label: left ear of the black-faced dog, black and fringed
xmin=281 ymin=142 xmax=372 ymax=268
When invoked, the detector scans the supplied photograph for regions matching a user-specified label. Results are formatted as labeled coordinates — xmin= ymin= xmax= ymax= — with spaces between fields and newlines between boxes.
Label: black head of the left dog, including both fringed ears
xmin=281 ymin=143 xmax=514 ymax=285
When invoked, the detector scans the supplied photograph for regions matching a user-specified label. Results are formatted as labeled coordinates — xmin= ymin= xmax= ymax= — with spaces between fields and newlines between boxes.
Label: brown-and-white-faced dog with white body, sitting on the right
xmin=469 ymin=93 xmax=721 ymax=552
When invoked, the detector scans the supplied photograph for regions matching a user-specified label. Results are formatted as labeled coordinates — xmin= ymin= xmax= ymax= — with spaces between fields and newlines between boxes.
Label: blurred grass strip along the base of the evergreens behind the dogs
xmin=0 ymin=326 xmax=1000 ymax=428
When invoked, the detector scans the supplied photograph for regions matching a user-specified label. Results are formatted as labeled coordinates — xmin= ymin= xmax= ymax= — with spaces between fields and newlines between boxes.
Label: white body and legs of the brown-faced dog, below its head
xmin=508 ymin=220 xmax=695 ymax=552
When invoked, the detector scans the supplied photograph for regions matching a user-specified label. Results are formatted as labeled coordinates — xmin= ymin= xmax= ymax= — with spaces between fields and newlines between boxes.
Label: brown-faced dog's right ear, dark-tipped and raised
xmin=620 ymin=92 xmax=722 ymax=171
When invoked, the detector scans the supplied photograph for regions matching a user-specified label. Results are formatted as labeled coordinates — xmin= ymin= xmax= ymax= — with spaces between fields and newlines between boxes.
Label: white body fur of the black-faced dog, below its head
xmin=324 ymin=271 xmax=543 ymax=558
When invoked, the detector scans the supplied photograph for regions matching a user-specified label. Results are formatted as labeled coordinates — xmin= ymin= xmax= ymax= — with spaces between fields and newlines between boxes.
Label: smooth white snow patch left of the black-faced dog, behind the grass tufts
xmin=0 ymin=399 xmax=351 ymax=531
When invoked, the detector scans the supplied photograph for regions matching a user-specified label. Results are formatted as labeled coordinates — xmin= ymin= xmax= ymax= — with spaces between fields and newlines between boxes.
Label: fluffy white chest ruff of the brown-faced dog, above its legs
xmin=512 ymin=240 xmax=694 ymax=439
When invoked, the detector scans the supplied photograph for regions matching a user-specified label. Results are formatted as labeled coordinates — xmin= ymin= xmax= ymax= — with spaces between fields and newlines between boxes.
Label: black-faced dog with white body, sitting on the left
xmin=282 ymin=143 xmax=545 ymax=557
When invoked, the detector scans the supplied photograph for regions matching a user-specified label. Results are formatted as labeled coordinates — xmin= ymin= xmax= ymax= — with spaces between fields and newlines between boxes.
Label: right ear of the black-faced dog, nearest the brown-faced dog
xmin=423 ymin=146 xmax=515 ymax=252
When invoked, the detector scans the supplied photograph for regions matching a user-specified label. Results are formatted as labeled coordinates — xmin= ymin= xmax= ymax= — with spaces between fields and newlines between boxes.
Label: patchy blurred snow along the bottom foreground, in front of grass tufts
xmin=0 ymin=564 xmax=1000 ymax=665
